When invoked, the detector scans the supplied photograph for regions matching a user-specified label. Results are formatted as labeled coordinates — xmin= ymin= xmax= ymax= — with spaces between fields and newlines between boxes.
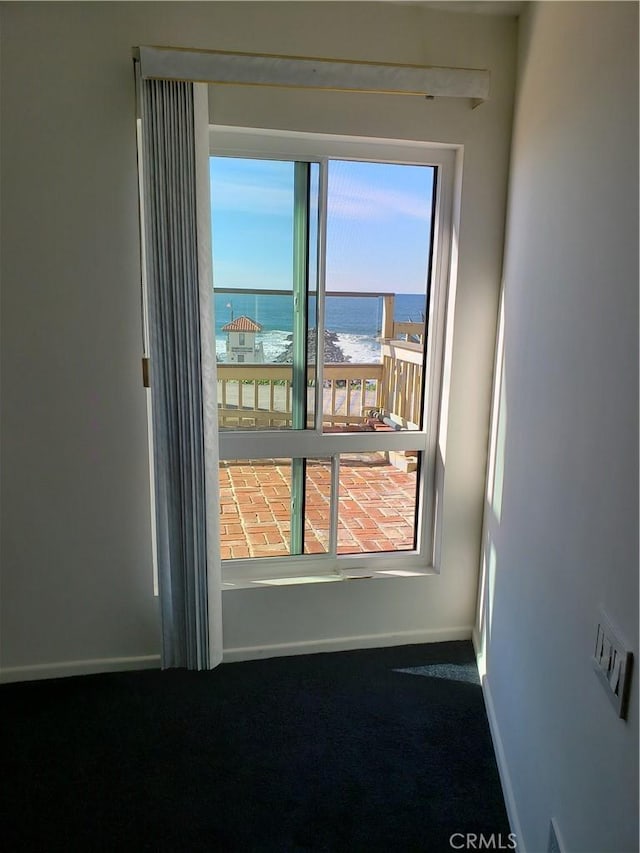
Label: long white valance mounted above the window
xmin=136 ymin=47 xmax=490 ymax=101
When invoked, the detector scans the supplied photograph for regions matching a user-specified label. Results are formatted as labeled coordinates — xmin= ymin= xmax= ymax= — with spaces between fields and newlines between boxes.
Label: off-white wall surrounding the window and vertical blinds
xmin=1 ymin=3 xmax=516 ymax=675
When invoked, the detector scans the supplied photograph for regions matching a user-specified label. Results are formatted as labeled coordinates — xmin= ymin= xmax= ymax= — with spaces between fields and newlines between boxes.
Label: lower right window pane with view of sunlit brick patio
xmin=338 ymin=451 xmax=419 ymax=554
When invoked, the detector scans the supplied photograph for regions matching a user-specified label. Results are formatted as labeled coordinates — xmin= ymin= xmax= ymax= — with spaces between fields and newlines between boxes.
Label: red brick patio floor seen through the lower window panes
xmin=220 ymin=453 xmax=416 ymax=560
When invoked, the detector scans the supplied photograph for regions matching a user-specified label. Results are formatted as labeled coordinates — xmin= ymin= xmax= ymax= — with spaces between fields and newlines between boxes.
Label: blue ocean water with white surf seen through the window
xmin=215 ymin=291 xmax=425 ymax=364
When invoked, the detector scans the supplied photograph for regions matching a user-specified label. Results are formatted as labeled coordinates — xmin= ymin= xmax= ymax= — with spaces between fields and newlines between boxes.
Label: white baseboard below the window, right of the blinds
xmin=222 ymin=625 xmax=471 ymax=663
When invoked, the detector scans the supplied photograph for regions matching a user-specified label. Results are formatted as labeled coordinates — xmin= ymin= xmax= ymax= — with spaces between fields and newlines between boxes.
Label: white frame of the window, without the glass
xmin=209 ymin=125 xmax=462 ymax=588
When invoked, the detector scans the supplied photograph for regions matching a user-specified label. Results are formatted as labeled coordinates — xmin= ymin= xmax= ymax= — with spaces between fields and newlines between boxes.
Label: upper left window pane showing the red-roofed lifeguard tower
xmin=210 ymin=157 xmax=317 ymax=430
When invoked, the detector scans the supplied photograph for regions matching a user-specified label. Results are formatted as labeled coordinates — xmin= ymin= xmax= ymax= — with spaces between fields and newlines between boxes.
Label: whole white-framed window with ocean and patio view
xmin=210 ymin=127 xmax=454 ymax=581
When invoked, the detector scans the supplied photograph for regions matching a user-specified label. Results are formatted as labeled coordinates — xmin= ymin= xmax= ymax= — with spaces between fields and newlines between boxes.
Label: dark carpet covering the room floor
xmin=0 ymin=642 xmax=509 ymax=853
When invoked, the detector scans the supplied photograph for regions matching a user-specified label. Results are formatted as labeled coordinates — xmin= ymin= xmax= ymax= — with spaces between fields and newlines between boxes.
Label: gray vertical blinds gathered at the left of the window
xmin=138 ymin=77 xmax=222 ymax=669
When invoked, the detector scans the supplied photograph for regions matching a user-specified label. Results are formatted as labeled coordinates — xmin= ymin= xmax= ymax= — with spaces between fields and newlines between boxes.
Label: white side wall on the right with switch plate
xmin=480 ymin=3 xmax=638 ymax=853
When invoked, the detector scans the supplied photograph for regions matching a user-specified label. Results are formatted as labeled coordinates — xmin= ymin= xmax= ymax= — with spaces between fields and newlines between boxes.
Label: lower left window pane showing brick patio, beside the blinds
xmin=220 ymin=459 xmax=291 ymax=560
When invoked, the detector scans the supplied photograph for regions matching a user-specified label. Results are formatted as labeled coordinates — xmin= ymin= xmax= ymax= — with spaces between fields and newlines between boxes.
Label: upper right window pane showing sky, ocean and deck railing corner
xmin=323 ymin=160 xmax=435 ymax=431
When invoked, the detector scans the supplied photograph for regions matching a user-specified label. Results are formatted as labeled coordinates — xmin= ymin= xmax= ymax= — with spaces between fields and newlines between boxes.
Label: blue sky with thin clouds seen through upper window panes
xmin=210 ymin=157 xmax=433 ymax=293
